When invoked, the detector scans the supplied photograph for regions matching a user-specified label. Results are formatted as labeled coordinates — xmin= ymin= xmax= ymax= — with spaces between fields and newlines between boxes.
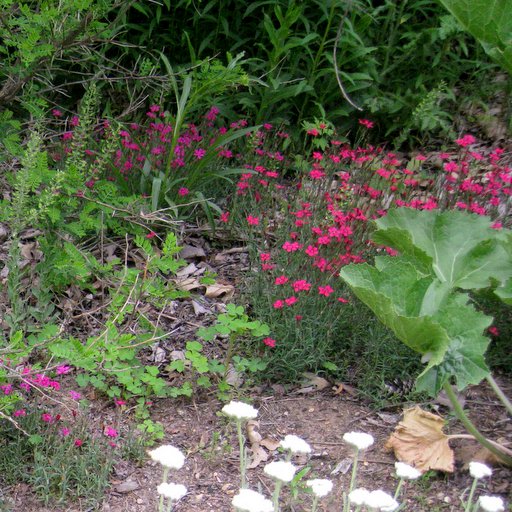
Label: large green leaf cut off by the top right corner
xmin=440 ymin=0 xmax=512 ymax=73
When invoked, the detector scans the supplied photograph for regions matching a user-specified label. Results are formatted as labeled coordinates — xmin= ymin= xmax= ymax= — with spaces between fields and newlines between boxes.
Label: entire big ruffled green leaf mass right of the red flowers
xmin=340 ymin=209 xmax=512 ymax=396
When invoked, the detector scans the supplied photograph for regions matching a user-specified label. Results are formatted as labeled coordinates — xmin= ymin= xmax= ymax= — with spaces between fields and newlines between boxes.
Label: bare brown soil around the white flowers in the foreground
xmin=5 ymin=382 xmax=512 ymax=512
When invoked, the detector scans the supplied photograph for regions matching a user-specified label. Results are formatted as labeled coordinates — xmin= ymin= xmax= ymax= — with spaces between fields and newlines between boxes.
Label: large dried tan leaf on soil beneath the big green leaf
xmin=386 ymin=406 xmax=454 ymax=473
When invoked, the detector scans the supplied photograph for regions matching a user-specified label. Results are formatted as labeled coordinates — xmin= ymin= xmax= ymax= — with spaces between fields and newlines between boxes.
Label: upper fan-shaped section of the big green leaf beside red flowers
xmin=373 ymin=208 xmax=512 ymax=290
